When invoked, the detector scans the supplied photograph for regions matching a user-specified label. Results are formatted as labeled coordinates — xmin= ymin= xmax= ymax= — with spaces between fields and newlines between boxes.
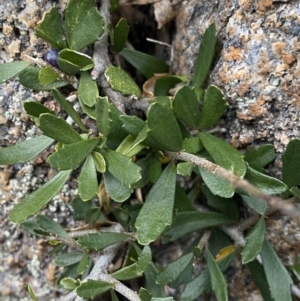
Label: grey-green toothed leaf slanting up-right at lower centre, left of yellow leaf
xmin=156 ymin=253 xmax=194 ymax=285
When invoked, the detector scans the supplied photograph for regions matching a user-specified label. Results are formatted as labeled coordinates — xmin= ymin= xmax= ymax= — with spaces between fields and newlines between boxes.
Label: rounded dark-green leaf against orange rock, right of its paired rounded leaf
xmin=199 ymin=85 xmax=227 ymax=130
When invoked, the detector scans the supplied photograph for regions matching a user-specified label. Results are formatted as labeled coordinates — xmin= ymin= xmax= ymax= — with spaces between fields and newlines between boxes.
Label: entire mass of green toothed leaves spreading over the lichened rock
xmin=0 ymin=0 xmax=300 ymax=301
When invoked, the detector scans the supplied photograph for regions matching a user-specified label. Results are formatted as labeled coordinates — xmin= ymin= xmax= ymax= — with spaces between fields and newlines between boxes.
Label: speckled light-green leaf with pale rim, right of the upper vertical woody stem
xmin=105 ymin=66 xmax=141 ymax=98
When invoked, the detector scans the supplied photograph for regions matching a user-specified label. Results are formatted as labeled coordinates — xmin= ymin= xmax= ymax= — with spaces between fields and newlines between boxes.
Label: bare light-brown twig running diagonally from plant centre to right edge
xmin=165 ymin=151 xmax=300 ymax=216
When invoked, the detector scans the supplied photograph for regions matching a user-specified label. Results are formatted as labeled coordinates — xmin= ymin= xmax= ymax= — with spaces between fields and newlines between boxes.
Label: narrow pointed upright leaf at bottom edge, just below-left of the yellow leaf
xmin=206 ymin=248 xmax=228 ymax=301
